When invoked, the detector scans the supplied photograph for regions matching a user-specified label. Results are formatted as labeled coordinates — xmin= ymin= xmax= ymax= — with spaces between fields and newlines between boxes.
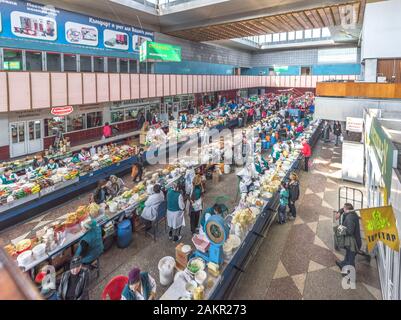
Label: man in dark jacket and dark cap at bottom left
xmin=58 ymin=256 xmax=89 ymax=300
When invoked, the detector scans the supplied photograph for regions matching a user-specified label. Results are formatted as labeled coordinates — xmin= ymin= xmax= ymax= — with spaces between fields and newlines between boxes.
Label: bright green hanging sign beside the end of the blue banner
xmin=139 ymin=41 xmax=181 ymax=62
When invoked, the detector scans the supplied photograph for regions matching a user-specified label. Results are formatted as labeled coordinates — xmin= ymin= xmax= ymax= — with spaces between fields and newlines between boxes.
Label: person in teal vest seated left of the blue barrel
xmin=75 ymin=219 xmax=104 ymax=265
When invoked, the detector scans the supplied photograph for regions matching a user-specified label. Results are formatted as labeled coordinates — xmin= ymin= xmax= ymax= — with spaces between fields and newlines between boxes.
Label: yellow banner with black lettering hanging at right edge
xmin=360 ymin=206 xmax=400 ymax=251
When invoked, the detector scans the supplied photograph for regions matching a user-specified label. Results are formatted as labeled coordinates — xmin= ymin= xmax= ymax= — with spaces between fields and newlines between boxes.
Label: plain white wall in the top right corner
xmin=362 ymin=0 xmax=401 ymax=60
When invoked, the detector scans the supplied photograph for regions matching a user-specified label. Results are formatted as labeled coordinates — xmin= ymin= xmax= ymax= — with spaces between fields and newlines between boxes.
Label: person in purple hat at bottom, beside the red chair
xmin=121 ymin=268 xmax=156 ymax=300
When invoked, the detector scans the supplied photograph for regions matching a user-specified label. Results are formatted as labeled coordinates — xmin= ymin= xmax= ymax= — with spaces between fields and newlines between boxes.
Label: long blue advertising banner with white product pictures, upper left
xmin=0 ymin=0 xmax=154 ymax=57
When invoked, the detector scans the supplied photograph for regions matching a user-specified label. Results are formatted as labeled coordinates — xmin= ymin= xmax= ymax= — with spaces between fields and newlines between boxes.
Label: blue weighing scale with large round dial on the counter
xmin=194 ymin=215 xmax=230 ymax=265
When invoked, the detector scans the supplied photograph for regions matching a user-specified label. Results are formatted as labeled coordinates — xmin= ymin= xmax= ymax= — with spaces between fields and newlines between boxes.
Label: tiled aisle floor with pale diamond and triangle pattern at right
xmin=231 ymin=142 xmax=381 ymax=300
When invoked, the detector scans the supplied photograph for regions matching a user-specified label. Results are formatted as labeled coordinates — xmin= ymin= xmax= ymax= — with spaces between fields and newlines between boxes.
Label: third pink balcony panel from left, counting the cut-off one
xmin=31 ymin=72 xmax=51 ymax=109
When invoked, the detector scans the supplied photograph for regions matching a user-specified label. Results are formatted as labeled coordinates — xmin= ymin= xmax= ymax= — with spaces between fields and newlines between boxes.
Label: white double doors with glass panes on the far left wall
xmin=10 ymin=120 xmax=43 ymax=158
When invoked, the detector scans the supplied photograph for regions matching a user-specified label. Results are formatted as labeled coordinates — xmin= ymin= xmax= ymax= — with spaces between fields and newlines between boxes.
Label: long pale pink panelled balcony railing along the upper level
xmin=0 ymin=72 xmax=356 ymax=112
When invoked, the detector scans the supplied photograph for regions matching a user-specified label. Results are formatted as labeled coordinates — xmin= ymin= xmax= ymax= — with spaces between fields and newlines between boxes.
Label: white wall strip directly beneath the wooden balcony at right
xmin=315 ymin=97 xmax=401 ymax=121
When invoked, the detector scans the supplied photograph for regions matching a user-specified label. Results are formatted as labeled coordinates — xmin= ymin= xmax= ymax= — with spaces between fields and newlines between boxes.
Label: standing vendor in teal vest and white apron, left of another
xmin=167 ymin=183 xmax=185 ymax=242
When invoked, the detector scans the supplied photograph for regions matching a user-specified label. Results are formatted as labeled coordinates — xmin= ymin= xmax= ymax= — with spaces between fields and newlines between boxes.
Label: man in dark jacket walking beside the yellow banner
xmin=336 ymin=203 xmax=362 ymax=270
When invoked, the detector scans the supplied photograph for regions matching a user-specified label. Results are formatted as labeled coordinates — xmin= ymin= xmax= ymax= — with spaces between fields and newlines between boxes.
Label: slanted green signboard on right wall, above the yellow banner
xmin=369 ymin=118 xmax=394 ymax=192
